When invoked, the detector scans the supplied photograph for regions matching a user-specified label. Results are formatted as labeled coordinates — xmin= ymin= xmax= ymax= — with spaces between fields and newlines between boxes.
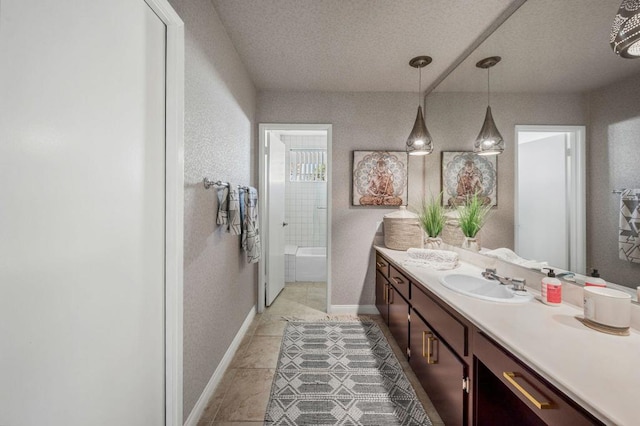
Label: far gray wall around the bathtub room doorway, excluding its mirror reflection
xmin=257 ymin=91 xmax=423 ymax=305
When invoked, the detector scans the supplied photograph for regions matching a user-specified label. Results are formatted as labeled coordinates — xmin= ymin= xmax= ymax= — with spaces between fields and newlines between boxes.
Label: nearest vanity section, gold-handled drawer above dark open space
xmin=473 ymin=331 xmax=603 ymax=426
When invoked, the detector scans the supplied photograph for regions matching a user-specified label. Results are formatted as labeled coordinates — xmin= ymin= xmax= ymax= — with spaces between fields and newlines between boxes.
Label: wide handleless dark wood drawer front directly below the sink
xmin=411 ymin=284 xmax=469 ymax=356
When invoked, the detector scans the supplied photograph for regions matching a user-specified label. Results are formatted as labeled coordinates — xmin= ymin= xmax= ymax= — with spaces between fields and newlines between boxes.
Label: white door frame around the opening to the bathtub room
xmin=258 ymin=123 xmax=333 ymax=313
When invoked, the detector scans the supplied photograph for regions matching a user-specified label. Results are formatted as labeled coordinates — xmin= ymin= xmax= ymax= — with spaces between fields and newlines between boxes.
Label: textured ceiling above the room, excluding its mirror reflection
xmin=212 ymin=0 xmax=520 ymax=91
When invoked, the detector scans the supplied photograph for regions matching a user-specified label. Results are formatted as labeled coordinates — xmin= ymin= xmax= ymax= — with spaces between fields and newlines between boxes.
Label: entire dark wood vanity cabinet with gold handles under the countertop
xmin=376 ymin=253 xmax=603 ymax=426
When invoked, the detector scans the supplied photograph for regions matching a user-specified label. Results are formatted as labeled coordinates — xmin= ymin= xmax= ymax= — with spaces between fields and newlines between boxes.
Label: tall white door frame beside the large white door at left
xmin=144 ymin=0 xmax=184 ymax=426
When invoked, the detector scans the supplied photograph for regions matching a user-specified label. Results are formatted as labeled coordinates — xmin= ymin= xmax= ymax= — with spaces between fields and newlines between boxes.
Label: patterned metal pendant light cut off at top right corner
xmin=609 ymin=0 xmax=640 ymax=59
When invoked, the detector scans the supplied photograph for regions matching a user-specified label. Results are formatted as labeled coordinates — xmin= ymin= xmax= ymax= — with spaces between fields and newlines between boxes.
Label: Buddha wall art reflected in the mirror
xmin=442 ymin=151 xmax=498 ymax=207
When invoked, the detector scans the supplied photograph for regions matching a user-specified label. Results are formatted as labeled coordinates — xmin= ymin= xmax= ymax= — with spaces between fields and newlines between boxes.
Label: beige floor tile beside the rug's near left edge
xmin=214 ymin=369 xmax=275 ymax=422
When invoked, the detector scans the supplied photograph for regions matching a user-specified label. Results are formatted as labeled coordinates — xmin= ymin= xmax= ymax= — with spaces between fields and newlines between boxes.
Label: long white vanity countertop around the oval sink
xmin=375 ymin=247 xmax=640 ymax=426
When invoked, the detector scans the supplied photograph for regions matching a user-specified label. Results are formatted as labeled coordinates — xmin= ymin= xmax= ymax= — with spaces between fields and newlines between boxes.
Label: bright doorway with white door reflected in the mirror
xmin=515 ymin=126 xmax=586 ymax=273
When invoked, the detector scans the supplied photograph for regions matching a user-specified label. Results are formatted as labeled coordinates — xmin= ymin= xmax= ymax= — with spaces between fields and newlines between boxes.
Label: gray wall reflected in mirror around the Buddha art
xmin=425 ymin=92 xmax=586 ymax=249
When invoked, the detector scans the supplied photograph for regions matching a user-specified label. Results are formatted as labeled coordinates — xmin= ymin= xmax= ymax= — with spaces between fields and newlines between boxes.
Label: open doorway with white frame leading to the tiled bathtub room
xmin=258 ymin=124 xmax=332 ymax=312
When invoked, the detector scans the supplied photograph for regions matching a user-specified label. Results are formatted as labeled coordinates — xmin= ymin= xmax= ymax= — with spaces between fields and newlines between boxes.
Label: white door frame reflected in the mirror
xmin=514 ymin=125 xmax=587 ymax=274
